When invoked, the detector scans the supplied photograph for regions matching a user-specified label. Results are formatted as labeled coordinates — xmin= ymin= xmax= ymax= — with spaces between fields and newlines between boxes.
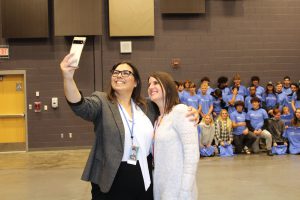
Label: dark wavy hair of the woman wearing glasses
xmin=107 ymin=61 xmax=146 ymax=108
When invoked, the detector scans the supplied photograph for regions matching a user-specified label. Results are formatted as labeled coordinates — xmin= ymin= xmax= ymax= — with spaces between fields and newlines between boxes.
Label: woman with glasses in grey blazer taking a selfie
xmin=60 ymin=54 xmax=197 ymax=200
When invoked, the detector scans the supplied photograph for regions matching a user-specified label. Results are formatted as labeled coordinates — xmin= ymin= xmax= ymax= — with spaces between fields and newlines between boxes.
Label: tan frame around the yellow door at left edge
xmin=0 ymin=70 xmax=28 ymax=152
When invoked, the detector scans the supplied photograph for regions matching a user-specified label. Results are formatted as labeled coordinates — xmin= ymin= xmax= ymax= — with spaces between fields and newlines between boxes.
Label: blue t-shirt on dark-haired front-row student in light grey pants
xmin=246 ymin=108 xmax=268 ymax=130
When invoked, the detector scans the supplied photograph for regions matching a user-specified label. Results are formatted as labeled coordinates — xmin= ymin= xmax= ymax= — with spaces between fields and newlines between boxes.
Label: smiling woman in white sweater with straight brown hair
xmin=148 ymin=72 xmax=199 ymax=200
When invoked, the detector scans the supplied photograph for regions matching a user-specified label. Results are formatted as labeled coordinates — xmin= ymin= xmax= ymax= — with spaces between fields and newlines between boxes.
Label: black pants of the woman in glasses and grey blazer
xmin=92 ymin=156 xmax=153 ymax=200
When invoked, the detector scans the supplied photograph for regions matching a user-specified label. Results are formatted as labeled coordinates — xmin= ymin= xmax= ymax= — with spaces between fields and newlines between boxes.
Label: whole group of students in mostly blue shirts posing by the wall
xmin=176 ymin=74 xmax=300 ymax=156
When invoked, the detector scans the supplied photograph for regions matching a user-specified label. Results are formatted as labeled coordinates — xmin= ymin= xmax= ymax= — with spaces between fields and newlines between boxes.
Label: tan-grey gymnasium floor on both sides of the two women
xmin=0 ymin=150 xmax=300 ymax=200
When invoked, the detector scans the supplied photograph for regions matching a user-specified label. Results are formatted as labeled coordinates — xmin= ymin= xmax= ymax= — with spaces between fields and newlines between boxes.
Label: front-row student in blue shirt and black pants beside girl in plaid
xmin=230 ymin=101 xmax=256 ymax=154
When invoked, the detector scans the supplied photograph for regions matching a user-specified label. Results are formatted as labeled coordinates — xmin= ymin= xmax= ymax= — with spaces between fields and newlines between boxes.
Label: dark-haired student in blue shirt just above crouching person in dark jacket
xmin=262 ymin=81 xmax=278 ymax=117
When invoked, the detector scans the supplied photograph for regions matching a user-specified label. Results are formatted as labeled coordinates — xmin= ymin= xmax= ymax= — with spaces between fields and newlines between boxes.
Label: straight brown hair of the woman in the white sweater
xmin=148 ymin=72 xmax=179 ymax=114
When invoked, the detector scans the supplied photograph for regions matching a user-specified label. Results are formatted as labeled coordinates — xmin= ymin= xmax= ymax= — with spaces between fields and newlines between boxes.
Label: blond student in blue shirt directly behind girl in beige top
xmin=198 ymin=83 xmax=213 ymax=118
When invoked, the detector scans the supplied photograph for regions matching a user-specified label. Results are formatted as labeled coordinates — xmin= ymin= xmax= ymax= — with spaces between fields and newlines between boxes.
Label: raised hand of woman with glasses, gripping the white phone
xmin=60 ymin=54 xmax=78 ymax=80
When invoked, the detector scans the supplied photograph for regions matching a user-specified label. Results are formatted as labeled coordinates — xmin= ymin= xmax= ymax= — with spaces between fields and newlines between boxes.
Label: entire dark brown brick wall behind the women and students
xmin=0 ymin=0 xmax=300 ymax=148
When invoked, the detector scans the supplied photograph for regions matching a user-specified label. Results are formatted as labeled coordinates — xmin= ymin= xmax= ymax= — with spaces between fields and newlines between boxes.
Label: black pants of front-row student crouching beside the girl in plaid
xmin=233 ymin=132 xmax=256 ymax=153
